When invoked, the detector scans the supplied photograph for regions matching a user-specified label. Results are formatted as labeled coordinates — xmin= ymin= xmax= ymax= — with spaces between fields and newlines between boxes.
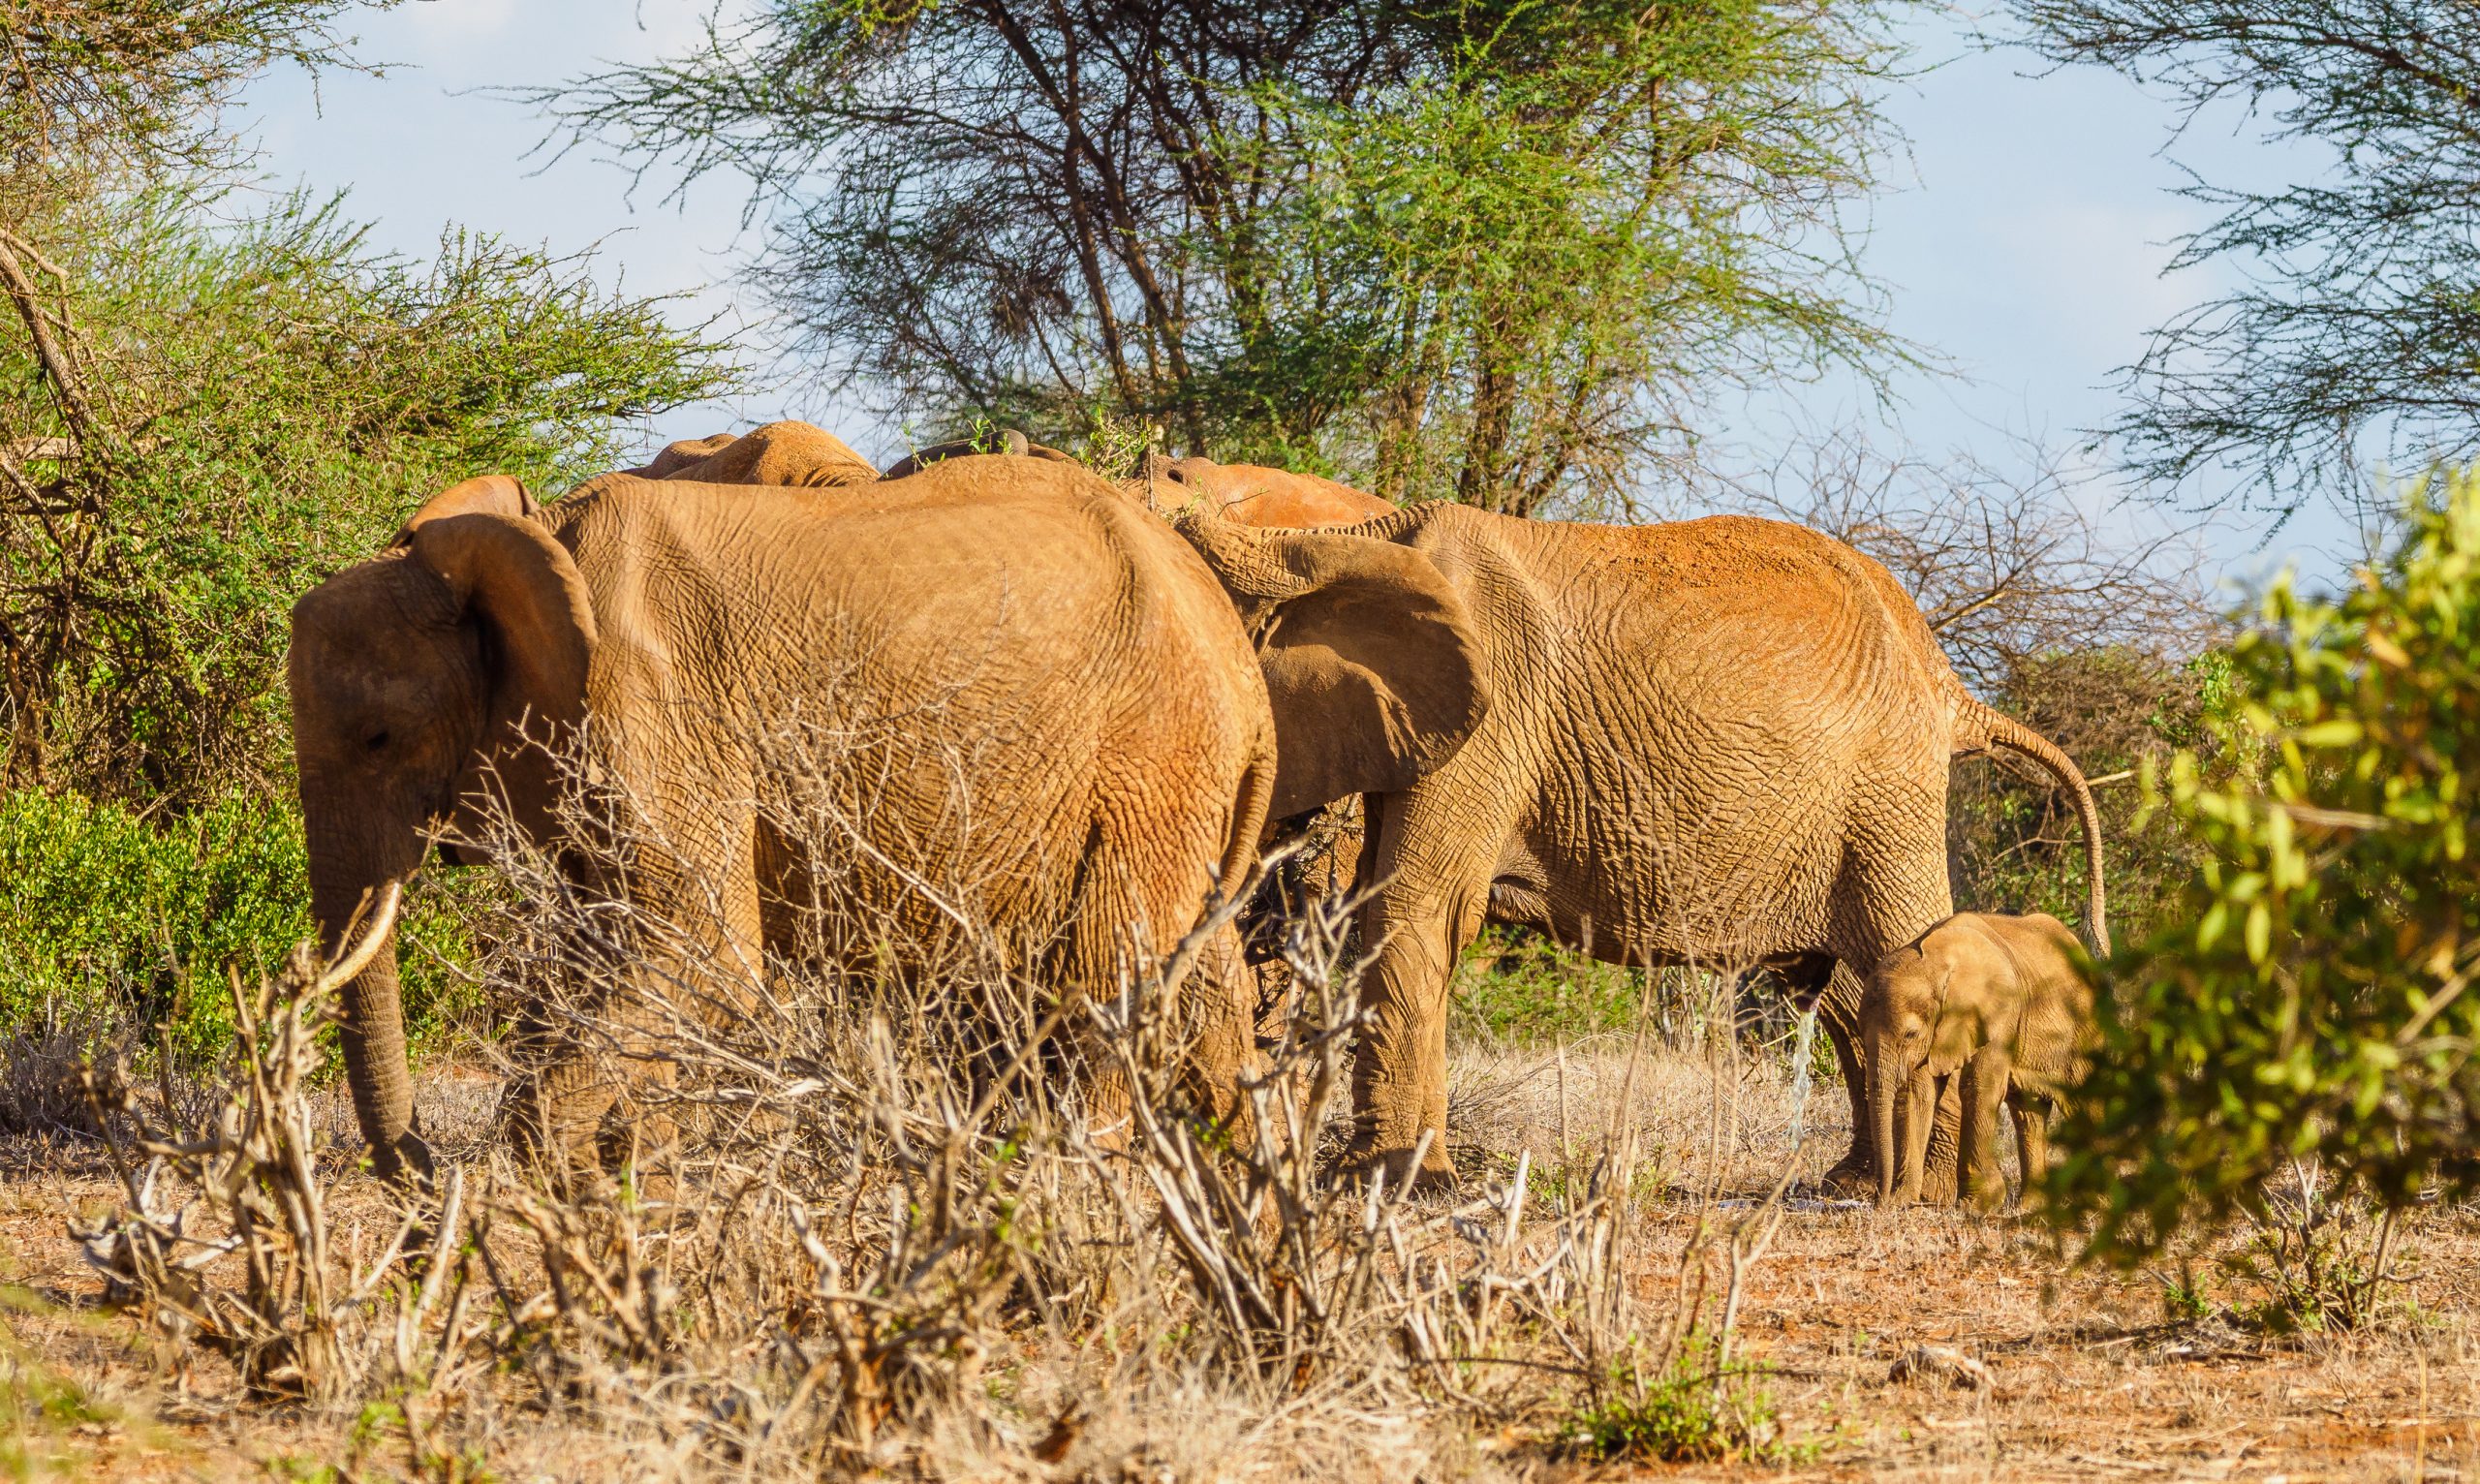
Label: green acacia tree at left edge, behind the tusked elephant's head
xmin=0 ymin=0 xmax=727 ymax=804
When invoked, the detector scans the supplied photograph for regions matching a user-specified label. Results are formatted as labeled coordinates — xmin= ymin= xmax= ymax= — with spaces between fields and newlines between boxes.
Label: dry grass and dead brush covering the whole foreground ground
xmin=0 ymin=744 xmax=2480 ymax=1484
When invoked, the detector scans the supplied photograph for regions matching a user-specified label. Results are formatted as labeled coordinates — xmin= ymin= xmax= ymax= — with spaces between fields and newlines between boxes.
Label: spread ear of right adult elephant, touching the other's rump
xmin=1181 ymin=511 xmax=1491 ymax=819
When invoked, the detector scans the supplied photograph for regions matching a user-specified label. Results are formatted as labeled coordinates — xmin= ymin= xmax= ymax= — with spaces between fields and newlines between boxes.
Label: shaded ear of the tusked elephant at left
xmin=407 ymin=510 xmax=595 ymax=739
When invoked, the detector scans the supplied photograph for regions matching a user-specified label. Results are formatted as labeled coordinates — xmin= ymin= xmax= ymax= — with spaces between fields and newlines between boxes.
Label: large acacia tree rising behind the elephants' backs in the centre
xmin=547 ymin=0 xmax=1892 ymax=509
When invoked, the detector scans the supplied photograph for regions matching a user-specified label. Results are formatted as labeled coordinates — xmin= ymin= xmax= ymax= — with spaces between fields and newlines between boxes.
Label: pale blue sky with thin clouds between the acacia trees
xmin=245 ymin=0 xmax=2351 ymax=588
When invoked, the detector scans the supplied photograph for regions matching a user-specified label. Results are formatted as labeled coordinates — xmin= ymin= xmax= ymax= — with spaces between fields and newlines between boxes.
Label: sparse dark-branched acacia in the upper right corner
xmin=2016 ymin=0 xmax=2480 ymax=509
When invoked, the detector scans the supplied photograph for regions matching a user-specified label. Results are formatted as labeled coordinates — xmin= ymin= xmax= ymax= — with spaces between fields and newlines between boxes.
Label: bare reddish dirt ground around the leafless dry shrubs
xmin=0 ymin=1045 xmax=2480 ymax=1484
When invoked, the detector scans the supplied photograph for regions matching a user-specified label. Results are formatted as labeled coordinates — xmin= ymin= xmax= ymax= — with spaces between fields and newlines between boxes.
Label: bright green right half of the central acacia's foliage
xmin=1240 ymin=0 xmax=1900 ymax=513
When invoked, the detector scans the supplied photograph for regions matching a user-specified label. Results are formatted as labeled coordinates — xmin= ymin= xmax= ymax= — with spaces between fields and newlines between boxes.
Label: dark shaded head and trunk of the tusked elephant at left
xmin=285 ymin=477 xmax=595 ymax=1174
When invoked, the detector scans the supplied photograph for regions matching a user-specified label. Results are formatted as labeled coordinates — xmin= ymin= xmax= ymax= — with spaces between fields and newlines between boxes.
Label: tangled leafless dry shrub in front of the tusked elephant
xmin=62 ymin=727 xmax=1825 ymax=1479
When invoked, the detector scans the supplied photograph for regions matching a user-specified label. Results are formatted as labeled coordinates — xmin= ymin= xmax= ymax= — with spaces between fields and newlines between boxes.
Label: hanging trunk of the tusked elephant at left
xmin=310 ymin=826 xmax=429 ymax=1176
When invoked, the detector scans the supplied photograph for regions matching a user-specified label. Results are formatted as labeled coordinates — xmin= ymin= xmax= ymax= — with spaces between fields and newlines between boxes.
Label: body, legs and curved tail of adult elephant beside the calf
xmin=1193 ymin=504 xmax=2108 ymax=1179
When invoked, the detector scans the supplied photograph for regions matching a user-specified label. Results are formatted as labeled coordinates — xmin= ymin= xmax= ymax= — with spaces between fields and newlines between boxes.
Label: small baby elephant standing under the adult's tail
xmin=1860 ymin=913 xmax=2093 ymax=1209
